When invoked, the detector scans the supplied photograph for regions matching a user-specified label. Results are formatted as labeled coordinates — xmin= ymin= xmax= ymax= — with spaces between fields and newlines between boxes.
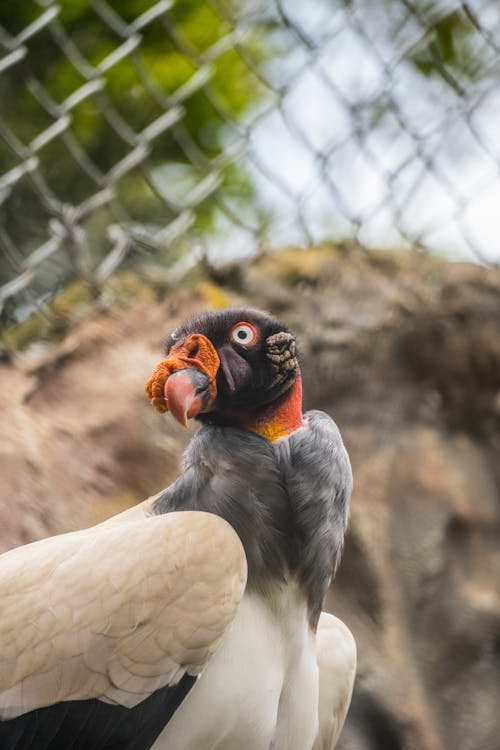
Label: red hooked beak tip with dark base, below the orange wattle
xmin=164 ymin=369 xmax=210 ymax=427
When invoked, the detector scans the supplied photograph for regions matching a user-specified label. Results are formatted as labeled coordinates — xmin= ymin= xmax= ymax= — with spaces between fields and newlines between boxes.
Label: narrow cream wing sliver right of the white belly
xmin=313 ymin=612 xmax=356 ymax=750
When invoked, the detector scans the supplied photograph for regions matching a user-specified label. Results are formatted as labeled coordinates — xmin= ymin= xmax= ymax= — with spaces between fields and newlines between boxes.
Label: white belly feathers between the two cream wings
xmin=154 ymin=587 xmax=318 ymax=750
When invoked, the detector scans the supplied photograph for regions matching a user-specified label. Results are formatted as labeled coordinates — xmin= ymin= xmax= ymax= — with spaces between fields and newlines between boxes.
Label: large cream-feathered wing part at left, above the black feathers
xmin=0 ymin=510 xmax=246 ymax=719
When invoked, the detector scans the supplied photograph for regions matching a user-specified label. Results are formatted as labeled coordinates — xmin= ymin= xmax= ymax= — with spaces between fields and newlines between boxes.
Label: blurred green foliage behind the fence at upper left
xmin=0 ymin=0 xmax=265 ymax=296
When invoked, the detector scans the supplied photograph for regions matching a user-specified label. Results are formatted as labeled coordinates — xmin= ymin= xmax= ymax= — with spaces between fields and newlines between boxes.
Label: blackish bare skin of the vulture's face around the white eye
xmin=166 ymin=307 xmax=297 ymax=424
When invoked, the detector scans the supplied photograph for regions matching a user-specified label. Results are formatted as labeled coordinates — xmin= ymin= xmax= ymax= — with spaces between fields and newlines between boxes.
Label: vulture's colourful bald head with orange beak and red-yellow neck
xmin=146 ymin=307 xmax=302 ymax=440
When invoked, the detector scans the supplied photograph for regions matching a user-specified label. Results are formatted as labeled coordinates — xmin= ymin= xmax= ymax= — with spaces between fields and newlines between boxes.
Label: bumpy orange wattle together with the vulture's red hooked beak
xmin=146 ymin=333 xmax=220 ymax=427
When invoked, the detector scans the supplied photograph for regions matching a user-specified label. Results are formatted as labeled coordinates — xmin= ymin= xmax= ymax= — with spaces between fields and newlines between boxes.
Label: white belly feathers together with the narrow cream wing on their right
xmin=154 ymin=585 xmax=356 ymax=750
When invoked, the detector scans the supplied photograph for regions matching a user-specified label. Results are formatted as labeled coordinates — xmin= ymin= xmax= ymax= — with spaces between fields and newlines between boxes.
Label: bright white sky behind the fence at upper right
xmin=206 ymin=0 xmax=500 ymax=263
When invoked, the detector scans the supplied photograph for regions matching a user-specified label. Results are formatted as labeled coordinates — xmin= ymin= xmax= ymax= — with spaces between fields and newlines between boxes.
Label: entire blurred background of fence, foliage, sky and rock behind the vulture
xmin=0 ymin=0 xmax=500 ymax=750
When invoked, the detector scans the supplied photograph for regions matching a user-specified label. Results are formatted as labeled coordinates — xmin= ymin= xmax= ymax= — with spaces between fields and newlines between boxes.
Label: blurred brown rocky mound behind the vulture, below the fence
xmin=0 ymin=247 xmax=500 ymax=750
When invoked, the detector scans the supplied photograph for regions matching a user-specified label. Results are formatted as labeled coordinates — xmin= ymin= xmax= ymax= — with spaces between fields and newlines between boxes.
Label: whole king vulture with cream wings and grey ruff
xmin=0 ymin=306 xmax=356 ymax=750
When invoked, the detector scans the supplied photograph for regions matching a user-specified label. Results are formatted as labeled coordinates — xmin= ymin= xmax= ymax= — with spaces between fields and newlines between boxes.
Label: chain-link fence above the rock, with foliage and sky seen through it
xmin=0 ymin=0 xmax=500 ymax=334
